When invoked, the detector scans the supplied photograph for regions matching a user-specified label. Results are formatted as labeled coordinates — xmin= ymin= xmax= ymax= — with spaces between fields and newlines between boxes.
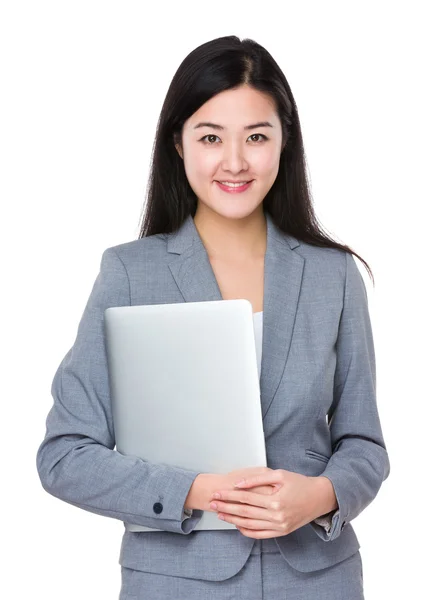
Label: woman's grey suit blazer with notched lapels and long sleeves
xmin=37 ymin=214 xmax=390 ymax=581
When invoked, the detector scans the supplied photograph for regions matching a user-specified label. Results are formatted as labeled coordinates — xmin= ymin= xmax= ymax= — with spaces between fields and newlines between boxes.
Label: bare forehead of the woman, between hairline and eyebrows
xmin=186 ymin=86 xmax=278 ymax=129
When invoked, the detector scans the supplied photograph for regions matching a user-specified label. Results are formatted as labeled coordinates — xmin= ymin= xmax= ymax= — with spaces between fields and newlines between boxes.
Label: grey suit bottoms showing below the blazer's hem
xmin=119 ymin=538 xmax=364 ymax=600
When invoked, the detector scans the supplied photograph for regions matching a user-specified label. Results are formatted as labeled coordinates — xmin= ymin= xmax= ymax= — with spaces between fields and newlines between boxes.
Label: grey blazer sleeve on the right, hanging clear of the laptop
xmin=310 ymin=252 xmax=390 ymax=541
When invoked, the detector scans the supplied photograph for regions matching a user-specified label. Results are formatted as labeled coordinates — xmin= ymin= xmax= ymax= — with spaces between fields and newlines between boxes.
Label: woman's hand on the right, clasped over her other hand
xmin=210 ymin=467 xmax=323 ymax=539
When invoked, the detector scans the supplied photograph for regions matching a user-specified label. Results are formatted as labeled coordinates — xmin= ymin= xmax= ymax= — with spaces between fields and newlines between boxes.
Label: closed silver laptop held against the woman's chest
xmin=104 ymin=299 xmax=267 ymax=531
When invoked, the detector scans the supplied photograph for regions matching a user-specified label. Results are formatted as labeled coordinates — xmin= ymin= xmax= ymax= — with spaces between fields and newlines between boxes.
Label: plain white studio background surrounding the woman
xmin=0 ymin=0 xmax=443 ymax=600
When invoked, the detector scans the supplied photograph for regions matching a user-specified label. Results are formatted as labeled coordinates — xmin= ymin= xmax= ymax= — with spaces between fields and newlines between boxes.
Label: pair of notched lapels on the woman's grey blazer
xmin=168 ymin=213 xmax=304 ymax=419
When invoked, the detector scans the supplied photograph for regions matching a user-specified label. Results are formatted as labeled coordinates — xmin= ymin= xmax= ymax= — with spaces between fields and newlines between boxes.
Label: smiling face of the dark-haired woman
xmin=176 ymin=86 xmax=282 ymax=219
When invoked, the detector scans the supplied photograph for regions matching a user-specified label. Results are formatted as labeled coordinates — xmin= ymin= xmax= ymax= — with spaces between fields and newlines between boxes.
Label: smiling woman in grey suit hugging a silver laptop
xmin=37 ymin=36 xmax=390 ymax=600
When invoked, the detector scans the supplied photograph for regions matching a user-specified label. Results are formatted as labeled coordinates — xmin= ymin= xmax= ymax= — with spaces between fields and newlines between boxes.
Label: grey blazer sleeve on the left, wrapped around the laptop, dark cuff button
xmin=36 ymin=248 xmax=203 ymax=534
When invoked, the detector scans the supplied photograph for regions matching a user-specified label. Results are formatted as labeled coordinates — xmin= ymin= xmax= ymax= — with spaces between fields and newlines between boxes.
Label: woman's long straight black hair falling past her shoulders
xmin=139 ymin=35 xmax=374 ymax=282
